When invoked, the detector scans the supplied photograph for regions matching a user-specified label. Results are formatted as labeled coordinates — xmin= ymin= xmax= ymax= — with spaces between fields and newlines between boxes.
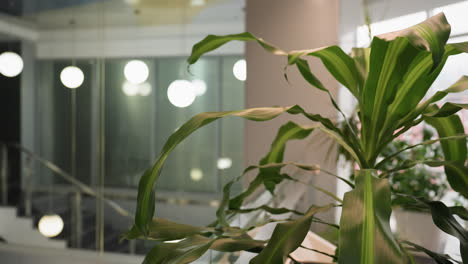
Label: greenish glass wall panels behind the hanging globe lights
xmin=38 ymin=56 xmax=244 ymax=193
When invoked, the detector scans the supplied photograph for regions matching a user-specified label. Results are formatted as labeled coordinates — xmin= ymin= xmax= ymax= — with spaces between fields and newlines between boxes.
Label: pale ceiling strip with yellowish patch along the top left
xmin=19 ymin=0 xmax=245 ymax=30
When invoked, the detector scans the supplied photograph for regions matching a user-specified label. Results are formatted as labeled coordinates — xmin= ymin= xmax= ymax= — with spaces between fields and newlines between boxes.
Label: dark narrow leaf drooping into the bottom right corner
xmin=427 ymin=201 xmax=468 ymax=263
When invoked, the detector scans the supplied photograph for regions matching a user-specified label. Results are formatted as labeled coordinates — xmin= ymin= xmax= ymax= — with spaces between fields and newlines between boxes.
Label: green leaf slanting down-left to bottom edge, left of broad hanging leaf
xmin=250 ymin=205 xmax=333 ymax=264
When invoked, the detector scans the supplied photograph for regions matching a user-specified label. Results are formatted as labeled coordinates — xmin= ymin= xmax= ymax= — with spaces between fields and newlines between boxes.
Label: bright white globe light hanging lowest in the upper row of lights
xmin=167 ymin=80 xmax=196 ymax=108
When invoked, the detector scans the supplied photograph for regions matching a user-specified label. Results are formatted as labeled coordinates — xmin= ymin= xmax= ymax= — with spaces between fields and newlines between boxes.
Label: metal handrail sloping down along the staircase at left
xmin=1 ymin=143 xmax=132 ymax=217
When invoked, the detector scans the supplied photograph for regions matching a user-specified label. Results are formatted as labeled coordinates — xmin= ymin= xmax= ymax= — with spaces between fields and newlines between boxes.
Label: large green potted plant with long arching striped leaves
xmin=125 ymin=14 xmax=468 ymax=264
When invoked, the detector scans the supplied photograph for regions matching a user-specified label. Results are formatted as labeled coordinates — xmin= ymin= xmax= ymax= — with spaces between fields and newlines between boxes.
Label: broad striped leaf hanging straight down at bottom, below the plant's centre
xmin=338 ymin=170 xmax=407 ymax=264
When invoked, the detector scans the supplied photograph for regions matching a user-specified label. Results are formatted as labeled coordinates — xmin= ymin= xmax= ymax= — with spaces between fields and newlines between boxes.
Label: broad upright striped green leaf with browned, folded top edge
xmin=360 ymin=14 xmax=458 ymax=163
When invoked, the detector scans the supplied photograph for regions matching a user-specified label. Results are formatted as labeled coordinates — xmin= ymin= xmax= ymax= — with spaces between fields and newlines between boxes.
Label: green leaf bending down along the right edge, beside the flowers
xmin=424 ymin=115 xmax=468 ymax=198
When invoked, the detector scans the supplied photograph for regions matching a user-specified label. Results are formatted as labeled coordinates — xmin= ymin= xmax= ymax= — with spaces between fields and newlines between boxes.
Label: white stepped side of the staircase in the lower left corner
xmin=0 ymin=207 xmax=66 ymax=249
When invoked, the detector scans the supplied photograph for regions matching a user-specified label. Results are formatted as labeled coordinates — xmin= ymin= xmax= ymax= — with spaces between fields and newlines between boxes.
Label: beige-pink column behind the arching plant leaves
xmin=244 ymin=0 xmax=339 ymax=228
